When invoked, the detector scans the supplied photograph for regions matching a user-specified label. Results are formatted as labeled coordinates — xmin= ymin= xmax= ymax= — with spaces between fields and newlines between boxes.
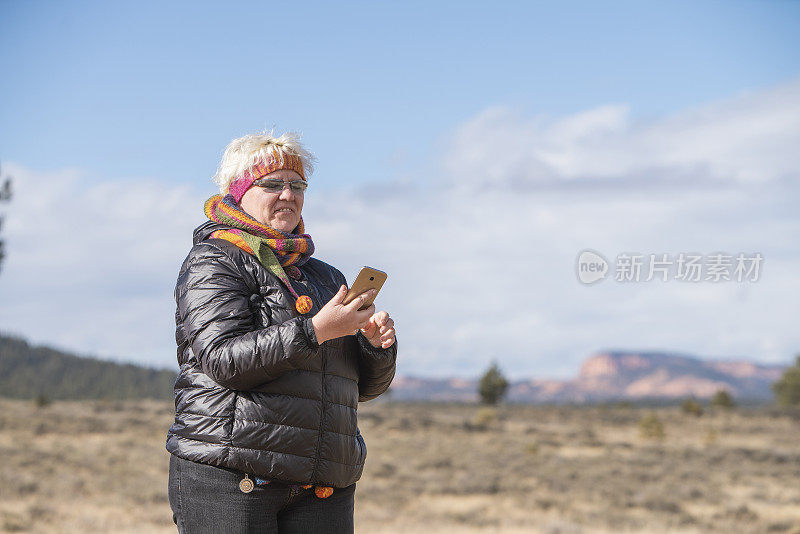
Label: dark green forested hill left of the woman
xmin=0 ymin=334 xmax=177 ymax=400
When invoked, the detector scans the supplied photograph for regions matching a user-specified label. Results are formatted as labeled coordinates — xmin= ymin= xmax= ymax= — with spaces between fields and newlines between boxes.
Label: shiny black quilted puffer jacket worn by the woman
xmin=167 ymin=221 xmax=397 ymax=487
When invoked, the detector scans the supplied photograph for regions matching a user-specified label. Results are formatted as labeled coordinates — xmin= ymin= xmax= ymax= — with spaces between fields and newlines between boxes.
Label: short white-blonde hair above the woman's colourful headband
xmin=213 ymin=130 xmax=316 ymax=195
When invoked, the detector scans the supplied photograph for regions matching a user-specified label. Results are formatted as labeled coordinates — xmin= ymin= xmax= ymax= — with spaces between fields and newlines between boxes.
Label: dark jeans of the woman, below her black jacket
xmin=169 ymin=454 xmax=356 ymax=534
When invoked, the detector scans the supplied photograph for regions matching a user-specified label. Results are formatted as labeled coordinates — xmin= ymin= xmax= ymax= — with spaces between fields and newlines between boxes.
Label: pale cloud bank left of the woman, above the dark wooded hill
xmin=0 ymin=165 xmax=209 ymax=367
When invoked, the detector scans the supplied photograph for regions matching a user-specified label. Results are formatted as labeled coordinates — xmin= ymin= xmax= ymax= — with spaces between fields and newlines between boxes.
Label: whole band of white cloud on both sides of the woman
xmin=0 ymin=78 xmax=800 ymax=377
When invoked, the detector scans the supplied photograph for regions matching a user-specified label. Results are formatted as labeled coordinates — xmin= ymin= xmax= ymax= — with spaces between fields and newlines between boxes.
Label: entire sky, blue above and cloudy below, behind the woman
xmin=0 ymin=1 xmax=800 ymax=379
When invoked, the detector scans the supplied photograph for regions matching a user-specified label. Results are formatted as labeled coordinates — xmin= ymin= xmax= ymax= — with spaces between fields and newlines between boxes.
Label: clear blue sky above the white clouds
xmin=0 ymin=2 xmax=800 ymax=187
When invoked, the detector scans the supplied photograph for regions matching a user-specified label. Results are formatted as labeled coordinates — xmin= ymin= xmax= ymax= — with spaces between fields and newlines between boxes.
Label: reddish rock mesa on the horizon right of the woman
xmin=391 ymin=351 xmax=787 ymax=403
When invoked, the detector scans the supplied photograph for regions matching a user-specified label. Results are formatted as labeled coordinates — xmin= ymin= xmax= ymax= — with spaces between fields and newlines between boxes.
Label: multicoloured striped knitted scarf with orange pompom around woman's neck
xmin=205 ymin=194 xmax=314 ymax=314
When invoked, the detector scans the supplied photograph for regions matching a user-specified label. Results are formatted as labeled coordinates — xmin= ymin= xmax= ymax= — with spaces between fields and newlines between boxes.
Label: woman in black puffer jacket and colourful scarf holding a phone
xmin=167 ymin=134 xmax=397 ymax=534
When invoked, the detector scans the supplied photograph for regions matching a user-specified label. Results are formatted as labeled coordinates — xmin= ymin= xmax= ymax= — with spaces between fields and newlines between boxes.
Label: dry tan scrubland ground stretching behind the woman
xmin=0 ymin=399 xmax=800 ymax=534
